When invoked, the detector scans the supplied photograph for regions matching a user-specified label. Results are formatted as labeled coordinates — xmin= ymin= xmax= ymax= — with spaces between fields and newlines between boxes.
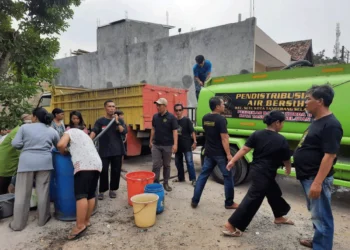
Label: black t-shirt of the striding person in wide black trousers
xmin=245 ymin=129 xmax=291 ymax=178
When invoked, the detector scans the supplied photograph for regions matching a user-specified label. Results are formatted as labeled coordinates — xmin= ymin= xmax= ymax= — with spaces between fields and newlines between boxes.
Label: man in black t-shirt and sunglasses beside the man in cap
xmin=174 ymin=104 xmax=197 ymax=186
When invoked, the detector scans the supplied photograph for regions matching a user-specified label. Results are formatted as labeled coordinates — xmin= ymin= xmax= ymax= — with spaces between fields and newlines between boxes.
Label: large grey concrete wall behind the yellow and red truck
xmin=55 ymin=18 xmax=255 ymax=106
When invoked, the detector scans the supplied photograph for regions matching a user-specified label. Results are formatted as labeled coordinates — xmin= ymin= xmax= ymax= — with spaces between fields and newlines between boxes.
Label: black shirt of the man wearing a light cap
xmin=152 ymin=111 xmax=177 ymax=146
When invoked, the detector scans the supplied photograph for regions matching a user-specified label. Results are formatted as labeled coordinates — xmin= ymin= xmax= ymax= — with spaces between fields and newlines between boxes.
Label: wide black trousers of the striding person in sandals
xmin=228 ymin=170 xmax=290 ymax=231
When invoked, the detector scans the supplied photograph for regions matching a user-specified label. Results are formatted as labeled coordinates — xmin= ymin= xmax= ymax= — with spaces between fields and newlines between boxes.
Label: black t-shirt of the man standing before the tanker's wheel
xmin=202 ymin=114 xmax=227 ymax=156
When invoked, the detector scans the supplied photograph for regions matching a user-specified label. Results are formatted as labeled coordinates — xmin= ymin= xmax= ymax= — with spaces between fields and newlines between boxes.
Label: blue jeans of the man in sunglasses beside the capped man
xmin=175 ymin=151 xmax=196 ymax=181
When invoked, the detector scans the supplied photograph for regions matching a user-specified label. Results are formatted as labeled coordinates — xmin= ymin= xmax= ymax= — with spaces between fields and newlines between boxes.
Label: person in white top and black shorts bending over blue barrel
xmin=57 ymin=128 xmax=102 ymax=240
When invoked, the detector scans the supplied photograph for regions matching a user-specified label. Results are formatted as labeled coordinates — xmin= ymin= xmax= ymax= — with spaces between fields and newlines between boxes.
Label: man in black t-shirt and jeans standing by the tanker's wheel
xmin=191 ymin=97 xmax=238 ymax=209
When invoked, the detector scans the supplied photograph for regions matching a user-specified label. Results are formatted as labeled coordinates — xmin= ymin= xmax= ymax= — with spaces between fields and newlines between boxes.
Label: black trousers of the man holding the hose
xmin=99 ymin=155 xmax=122 ymax=193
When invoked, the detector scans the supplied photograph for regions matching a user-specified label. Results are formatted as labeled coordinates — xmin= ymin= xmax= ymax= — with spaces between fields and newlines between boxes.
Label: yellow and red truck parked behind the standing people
xmin=39 ymin=84 xmax=188 ymax=156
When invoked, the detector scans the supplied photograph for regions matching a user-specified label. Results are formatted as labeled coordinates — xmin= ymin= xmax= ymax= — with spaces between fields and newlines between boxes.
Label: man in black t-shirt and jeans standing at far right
xmin=294 ymin=84 xmax=343 ymax=250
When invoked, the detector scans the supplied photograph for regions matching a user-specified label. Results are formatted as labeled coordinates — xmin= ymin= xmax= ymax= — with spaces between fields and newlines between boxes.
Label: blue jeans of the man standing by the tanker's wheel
xmin=192 ymin=156 xmax=234 ymax=206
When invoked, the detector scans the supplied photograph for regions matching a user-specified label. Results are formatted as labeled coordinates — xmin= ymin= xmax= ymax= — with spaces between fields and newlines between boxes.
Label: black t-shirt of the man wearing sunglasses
xmin=177 ymin=116 xmax=194 ymax=153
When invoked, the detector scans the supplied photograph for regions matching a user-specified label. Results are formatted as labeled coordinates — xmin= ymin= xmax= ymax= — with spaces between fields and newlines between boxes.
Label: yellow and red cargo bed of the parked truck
xmin=53 ymin=84 xmax=188 ymax=130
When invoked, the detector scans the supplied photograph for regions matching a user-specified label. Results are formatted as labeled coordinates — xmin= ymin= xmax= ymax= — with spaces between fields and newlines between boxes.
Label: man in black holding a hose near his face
xmin=90 ymin=100 xmax=126 ymax=200
